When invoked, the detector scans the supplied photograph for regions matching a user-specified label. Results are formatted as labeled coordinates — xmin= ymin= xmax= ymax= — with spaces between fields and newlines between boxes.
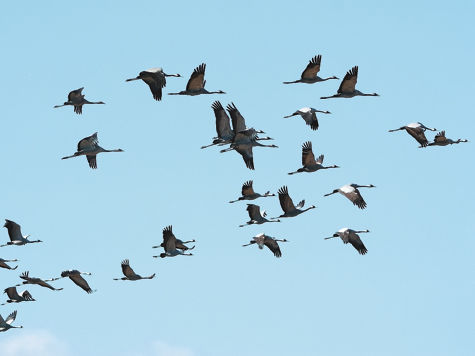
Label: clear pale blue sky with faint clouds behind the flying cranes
xmin=0 ymin=0 xmax=475 ymax=356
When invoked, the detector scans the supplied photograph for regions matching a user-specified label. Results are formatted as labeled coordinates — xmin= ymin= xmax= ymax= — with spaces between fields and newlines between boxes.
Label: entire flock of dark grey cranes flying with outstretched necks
xmin=0 ymin=55 xmax=468 ymax=331
